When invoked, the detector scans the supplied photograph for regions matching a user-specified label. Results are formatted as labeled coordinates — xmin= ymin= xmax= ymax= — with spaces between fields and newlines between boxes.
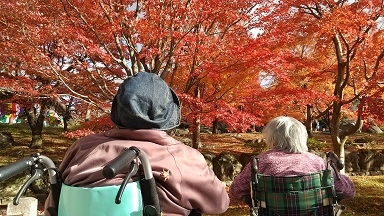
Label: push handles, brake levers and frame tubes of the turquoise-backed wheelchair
xmin=0 ymin=147 xmax=161 ymax=216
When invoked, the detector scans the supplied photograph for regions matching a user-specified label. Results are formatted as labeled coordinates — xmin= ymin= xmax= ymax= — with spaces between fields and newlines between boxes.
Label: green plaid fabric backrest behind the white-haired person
xmin=252 ymin=170 xmax=336 ymax=216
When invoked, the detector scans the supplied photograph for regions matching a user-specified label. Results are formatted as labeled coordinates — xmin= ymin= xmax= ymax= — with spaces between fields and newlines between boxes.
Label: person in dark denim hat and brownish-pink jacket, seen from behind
xmin=45 ymin=72 xmax=229 ymax=216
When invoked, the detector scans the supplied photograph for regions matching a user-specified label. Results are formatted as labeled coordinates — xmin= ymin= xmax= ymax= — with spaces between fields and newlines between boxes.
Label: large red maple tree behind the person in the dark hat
xmin=0 ymin=0 xmax=268 ymax=147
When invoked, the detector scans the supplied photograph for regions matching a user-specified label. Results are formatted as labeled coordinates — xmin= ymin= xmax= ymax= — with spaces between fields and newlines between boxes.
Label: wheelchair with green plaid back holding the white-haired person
xmin=245 ymin=152 xmax=345 ymax=216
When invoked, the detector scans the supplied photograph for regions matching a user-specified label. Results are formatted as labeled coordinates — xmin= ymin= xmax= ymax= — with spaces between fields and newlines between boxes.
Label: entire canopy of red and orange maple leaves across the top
xmin=0 ymin=0 xmax=384 ymax=140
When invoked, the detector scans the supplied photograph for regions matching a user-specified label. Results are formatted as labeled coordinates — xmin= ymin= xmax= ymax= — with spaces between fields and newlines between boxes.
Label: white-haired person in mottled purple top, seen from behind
xmin=230 ymin=116 xmax=355 ymax=200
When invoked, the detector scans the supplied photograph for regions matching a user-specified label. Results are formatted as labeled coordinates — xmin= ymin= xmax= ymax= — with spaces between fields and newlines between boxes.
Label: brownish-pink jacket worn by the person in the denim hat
xmin=45 ymin=129 xmax=229 ymax=216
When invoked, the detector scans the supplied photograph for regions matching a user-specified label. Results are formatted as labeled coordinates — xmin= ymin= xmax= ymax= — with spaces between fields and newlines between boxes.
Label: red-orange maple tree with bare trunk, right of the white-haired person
xmin=250 ymin=0 xmax=384 ymax=169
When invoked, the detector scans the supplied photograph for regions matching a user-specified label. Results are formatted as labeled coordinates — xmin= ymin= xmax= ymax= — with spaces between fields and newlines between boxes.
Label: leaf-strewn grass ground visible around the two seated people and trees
xmin=0 ymin=124 xmax=384 ymax=216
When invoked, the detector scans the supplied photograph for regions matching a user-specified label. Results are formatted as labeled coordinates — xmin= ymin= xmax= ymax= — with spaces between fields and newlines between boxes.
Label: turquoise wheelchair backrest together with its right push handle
xmin=58 ymin=146 xmax=161 ymax=216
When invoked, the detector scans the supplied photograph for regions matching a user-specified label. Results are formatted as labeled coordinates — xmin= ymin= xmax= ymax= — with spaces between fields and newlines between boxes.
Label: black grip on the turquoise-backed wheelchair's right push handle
xmin=103 ymin=147 xmax=140 ymax=179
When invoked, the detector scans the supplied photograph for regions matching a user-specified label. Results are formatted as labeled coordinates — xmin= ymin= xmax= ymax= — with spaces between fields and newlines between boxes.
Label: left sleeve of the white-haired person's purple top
xmin=229 ymin=163 xmax=251 ymax=200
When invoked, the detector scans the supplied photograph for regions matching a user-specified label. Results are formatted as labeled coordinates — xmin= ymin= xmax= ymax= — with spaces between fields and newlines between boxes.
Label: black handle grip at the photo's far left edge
xmin=0 ymin=156 xmax=36 ymax=182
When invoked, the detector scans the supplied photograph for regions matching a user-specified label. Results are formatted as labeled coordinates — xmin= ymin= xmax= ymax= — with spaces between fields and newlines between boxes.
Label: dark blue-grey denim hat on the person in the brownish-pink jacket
xmin=111 ymin=72 xmax=180 ymax=130
